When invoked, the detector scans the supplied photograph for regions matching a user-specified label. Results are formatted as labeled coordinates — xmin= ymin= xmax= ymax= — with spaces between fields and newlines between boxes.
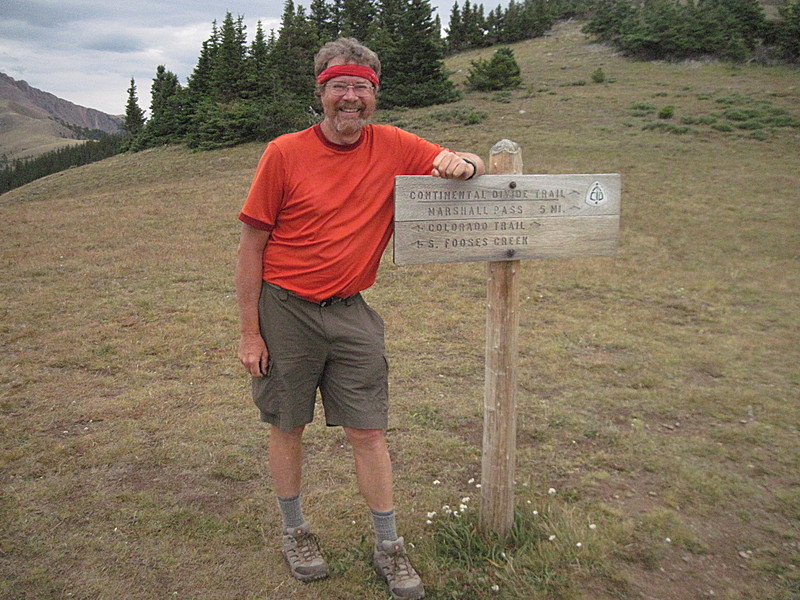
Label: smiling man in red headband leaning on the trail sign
xmin=236 ymin=38 xmax=484 ymax=600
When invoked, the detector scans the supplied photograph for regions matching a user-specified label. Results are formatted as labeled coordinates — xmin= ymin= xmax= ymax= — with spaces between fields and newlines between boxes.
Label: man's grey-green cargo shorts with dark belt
xmin=253 ymin=282 xmax=389 ymax=431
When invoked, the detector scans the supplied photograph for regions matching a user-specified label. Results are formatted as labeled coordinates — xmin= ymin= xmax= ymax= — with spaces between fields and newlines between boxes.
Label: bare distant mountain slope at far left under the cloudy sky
xmin=0 ymin=73 xmax=123 ymax=160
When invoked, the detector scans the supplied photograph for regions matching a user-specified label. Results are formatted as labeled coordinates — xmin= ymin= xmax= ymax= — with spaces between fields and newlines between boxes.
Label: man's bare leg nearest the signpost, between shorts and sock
xmin=344 ymin=427 xmax=394 ymax=512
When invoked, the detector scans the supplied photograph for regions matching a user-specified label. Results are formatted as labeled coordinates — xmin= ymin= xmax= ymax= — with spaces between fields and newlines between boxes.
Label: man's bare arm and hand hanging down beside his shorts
xmin=236 ymin=223 xmax=269 ymax=377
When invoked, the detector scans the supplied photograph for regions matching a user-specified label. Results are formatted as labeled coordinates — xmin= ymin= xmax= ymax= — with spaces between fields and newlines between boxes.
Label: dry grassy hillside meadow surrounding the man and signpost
xmin=0 ymin=23 xmax=800 ymax=600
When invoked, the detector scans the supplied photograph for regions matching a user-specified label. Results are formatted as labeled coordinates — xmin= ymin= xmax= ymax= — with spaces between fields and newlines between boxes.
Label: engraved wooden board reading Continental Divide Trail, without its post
xmin=394 ymin=174 xmax=622 ymax=265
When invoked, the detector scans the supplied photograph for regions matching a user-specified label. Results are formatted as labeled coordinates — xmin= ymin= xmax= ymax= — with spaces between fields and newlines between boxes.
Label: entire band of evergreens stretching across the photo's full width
xmin=0 ymin=0 xmax=800 ymax=193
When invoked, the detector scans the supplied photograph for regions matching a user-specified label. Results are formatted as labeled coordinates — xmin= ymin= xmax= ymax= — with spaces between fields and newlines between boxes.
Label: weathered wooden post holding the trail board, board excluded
xmin=481 ymin=140 xmax=522 ymax=535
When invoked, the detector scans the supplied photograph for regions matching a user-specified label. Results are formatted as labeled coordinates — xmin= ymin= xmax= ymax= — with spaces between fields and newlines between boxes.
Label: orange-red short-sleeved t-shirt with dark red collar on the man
xmin=239 ymin=125 xmax=443 ymax=301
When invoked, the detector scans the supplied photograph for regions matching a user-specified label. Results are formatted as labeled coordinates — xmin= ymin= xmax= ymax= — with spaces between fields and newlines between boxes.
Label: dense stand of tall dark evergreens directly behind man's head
xmin=120 ymin=0 xmax=584 ymax=150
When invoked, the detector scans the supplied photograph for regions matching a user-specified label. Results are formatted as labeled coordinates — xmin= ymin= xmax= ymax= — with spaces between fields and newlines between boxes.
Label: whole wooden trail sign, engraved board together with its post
xmin=394 ymin=140 xmax=621 ymax=535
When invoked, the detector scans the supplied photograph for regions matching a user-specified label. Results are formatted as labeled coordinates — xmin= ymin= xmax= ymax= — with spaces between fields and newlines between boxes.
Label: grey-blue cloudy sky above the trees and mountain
xmin=0 ymin=0 xmax=500 ymax=115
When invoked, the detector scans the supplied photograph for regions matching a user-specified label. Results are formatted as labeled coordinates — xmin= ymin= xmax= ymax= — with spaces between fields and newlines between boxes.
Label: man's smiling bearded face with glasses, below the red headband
xmin=320 ymin=59 xmax=377 ymax=144
